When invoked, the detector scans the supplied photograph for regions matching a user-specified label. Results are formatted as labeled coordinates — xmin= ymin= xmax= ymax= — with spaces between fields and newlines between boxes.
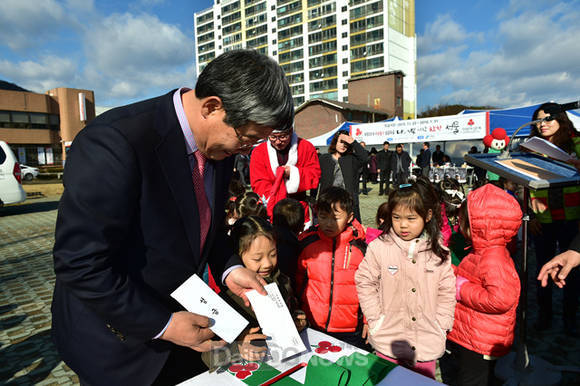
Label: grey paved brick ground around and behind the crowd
xmin=0 ymin=184 xmax=580 ymax=385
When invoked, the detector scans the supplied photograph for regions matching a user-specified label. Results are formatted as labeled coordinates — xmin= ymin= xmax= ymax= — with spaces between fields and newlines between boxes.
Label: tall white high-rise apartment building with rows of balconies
xmin=194 ymin=0 xmax=417 ymax=118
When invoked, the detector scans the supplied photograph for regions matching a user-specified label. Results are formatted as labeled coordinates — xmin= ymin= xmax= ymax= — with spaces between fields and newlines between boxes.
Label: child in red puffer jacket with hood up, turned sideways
xmin=440 ymin=184 xmax=522 ymax=385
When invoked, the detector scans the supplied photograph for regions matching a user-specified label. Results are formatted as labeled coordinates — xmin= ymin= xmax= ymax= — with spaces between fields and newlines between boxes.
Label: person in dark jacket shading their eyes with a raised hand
xmin=319 ymin=130 xmax=368 ymax=222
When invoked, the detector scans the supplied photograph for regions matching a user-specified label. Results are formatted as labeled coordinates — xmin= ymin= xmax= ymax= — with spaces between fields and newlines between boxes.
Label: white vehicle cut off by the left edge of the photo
xmin=0 ymin=141 xmax=26 ymax=206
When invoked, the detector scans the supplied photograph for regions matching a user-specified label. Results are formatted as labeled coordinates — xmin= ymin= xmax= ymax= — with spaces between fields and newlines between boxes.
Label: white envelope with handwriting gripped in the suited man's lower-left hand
xmin=171 ymin=274 xmax=248 ymax=343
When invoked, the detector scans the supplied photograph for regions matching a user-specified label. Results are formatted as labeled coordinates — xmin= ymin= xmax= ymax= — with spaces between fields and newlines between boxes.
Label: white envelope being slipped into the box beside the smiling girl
xmin=246 ymin=283 xmax=306 ymax=360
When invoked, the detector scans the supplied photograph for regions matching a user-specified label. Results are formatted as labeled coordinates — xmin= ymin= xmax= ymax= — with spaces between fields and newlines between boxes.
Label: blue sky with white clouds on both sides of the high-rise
xmin=0 ymin=0 xmax=580 ymax=111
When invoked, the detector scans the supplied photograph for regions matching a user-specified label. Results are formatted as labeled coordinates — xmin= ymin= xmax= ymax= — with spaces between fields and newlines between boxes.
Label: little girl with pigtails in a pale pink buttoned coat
xmin=355 ymin=181 xmax=455 ymax=378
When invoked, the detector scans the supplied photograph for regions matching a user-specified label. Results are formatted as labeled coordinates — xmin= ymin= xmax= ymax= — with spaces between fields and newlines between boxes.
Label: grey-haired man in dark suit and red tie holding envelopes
xmin=52 ymin=50 xmax=294 ymax=385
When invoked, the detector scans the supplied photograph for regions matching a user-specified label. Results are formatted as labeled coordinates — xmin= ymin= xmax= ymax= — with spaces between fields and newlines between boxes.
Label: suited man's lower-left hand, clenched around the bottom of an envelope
xmin=161 ymin=311 xmax=226 ymax=352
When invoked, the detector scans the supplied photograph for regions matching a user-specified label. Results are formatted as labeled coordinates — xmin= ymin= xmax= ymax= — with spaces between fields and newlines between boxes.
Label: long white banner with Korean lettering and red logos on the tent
xmin=351 ymin=112 xmax=488 ymax=144
